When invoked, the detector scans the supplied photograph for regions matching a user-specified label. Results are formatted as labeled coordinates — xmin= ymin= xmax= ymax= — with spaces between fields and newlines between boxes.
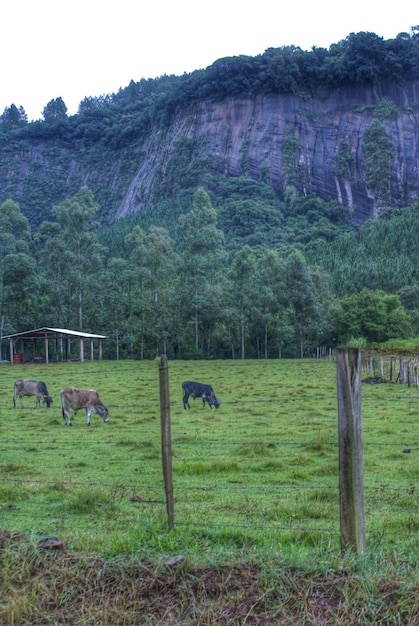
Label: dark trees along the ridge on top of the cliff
xmin=0 ymin=26 xmax=419 ymax=136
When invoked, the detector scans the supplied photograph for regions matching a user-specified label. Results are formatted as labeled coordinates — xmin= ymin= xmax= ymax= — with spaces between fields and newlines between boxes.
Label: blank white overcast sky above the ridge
xmin=0 ymin=0 xmax=419 ymax=120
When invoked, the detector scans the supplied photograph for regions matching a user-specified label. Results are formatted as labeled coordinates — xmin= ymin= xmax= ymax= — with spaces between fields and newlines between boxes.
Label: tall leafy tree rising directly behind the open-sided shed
xmin=40 ymin=187 xmax=105 ymax=330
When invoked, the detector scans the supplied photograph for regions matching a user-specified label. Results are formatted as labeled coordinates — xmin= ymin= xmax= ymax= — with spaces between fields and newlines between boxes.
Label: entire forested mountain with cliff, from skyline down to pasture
xmin=0 ymin=28 xmax=419 ymax=358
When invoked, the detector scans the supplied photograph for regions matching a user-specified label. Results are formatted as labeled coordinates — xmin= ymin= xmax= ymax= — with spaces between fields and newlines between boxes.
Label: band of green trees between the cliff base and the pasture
xmin=0 ymin=187 xmax=419 ymax=359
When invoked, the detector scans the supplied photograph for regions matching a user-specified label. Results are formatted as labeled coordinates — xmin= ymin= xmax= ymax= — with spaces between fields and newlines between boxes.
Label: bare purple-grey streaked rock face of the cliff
xmin=116 ymin=83 xmax=419 ymax=224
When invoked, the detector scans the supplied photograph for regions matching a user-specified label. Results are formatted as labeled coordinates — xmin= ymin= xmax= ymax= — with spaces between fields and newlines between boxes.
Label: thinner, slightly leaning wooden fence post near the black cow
xmin=159 ymin=355 xmax=174 ymax=530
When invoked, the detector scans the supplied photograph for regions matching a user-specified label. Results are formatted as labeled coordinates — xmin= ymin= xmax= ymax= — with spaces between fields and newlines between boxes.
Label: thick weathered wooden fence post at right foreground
xmin=336 ymin=348 xmax=365 ymax=554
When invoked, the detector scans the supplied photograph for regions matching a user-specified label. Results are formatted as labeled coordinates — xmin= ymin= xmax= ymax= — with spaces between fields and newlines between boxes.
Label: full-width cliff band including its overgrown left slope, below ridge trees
xmin=0 ymin=82 xmax=419 ymax=224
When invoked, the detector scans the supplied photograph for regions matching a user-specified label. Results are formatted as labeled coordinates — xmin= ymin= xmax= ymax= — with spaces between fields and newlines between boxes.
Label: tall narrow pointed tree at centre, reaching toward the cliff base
xmin=179 ymin=187 xmax=227 ymax=351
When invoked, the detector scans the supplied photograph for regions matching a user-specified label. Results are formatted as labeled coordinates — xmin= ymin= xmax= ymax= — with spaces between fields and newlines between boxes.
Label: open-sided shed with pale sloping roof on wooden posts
xmin=3 ymin=327 xmax=107 ymax=363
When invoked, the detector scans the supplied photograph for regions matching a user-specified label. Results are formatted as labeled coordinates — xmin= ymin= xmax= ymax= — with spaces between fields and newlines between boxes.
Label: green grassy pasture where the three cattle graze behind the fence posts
xmin=0 ymin=360 xmax=419 ymax=567
